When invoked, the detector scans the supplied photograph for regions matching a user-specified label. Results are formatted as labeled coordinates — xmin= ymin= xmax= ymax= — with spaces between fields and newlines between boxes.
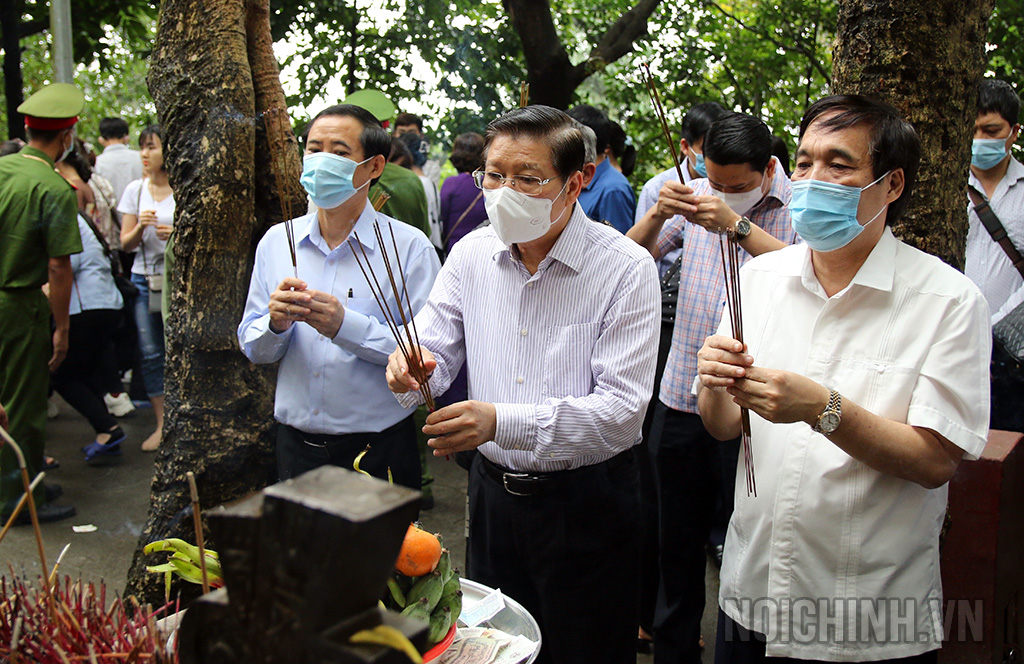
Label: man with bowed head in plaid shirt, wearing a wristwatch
xmin=627 ymin=113 xmax=796 ymax=664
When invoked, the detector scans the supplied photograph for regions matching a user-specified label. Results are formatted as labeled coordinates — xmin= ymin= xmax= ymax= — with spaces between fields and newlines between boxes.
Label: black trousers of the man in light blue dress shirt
xmin=278 ymin=415 xmax=420 ymax=491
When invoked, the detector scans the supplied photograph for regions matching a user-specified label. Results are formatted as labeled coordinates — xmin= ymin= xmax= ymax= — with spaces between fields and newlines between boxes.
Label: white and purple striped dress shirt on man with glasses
xmin=398 ymin=205 xmax=659 ymax=471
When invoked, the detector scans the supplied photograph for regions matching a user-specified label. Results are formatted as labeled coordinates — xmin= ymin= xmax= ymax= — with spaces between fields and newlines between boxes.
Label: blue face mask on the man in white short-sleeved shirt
xmin=790 ymin=171 xmax=891 ymax=251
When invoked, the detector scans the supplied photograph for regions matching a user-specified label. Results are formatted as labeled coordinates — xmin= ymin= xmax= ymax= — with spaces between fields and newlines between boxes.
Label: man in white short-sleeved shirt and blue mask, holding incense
xmin=694 ymin=96 xmax=990 ymax=663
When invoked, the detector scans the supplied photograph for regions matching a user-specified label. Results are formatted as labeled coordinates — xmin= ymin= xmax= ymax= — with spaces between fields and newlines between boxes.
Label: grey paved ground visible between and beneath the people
xmin=0 ymin=397 xmax=718 ymax=664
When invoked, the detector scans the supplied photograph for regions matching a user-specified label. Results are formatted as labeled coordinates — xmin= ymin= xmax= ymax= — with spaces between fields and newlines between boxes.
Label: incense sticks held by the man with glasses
xmin=348 ymin=192 xmax=434 ymax=412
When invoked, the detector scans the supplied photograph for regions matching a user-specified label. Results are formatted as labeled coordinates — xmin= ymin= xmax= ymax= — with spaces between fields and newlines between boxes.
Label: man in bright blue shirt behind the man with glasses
xmin=568 ymin=105 xmax=637 ymax=233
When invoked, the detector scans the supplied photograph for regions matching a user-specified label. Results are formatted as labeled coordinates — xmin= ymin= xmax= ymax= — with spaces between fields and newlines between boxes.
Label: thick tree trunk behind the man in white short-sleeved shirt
xmin=833 ymin=0 xmax=994 ymax=269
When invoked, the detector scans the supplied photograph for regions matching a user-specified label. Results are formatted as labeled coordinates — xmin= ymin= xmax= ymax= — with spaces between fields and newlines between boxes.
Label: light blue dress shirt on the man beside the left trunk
xmin=239 ymin=204 xmax=440 ymax=434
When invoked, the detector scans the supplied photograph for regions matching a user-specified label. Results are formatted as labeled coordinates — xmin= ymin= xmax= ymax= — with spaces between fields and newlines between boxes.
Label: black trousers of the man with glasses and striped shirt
xmin=469 ymin=451 xmax=639 ymax=664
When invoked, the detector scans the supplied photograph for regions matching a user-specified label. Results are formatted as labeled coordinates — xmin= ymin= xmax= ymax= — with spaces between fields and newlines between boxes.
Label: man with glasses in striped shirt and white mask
xmin=387 ymin=107 xmax=658 ymax=664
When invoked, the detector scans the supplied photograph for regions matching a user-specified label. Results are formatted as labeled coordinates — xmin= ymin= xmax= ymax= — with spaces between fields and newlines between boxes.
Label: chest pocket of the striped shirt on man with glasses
xmin=543 ymin=323 xmax=600 ymax=399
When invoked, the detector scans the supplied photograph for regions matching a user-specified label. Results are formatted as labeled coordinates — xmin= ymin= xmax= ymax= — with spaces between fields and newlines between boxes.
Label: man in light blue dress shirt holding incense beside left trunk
xmin=239 ymin=105 xmax=440 ymax=489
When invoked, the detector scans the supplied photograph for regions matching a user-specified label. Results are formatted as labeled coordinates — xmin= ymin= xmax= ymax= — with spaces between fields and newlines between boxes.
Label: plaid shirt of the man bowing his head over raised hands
xmin=657 ymin=157 xmax=797 ymax=413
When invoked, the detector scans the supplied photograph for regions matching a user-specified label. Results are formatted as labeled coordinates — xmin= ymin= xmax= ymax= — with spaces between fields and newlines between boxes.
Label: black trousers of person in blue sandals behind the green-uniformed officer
xmin=50 ymin=309 xmax=122 ymax=433
